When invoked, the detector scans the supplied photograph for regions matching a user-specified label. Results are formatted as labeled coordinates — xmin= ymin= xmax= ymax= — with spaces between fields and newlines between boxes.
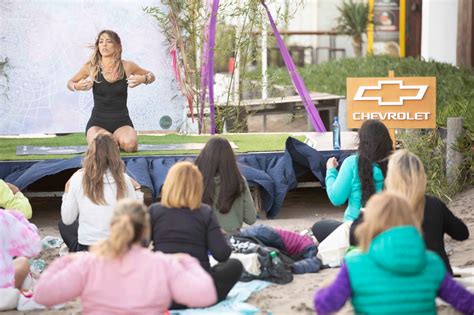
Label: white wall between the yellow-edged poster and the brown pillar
xmin=421 ymin=0 xmax=458 ymax=65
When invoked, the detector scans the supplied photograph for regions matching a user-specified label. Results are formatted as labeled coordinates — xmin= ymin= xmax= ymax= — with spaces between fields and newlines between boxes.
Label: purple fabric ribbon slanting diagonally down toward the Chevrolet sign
xmin=262 ymin=1 xmax=326 ymax=132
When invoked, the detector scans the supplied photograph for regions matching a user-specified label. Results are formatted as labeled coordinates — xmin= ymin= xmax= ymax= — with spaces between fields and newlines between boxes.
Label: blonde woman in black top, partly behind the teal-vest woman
xmin=385 ymin=150 xmax=469 ymax=274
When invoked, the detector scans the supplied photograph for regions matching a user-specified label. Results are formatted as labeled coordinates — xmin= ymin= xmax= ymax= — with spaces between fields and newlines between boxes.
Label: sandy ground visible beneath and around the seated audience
xmin=7 ymin=187 xmax=474 ymax=315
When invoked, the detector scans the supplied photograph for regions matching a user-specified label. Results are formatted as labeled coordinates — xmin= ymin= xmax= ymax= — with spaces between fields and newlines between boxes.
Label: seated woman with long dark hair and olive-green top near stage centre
xmin=195 ymin=137 xmax=257 ymax=233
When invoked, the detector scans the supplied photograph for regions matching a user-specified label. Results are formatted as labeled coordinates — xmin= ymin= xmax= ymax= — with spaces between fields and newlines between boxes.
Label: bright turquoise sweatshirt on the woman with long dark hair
xmin=326 ymin=155 xmax=384 ymax=222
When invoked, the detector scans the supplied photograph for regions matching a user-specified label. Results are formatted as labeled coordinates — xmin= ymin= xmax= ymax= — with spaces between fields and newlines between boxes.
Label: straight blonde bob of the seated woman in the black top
xmin=161 ymin=162 xmax=203 ymax=210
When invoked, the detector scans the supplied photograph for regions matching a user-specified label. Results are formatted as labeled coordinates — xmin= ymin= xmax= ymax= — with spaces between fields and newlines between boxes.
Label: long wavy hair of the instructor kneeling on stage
xmin=86 ymin=30 xmax=125 ymax=83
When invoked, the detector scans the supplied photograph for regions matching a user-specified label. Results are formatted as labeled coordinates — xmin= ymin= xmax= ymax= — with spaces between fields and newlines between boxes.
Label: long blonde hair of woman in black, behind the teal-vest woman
xmin=385 ymin=150 xmax=426 ymax=224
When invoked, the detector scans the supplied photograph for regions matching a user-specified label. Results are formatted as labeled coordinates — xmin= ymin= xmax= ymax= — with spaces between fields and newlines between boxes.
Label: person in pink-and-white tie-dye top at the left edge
xmin=0 ymin=209 xmax=41 ymax=289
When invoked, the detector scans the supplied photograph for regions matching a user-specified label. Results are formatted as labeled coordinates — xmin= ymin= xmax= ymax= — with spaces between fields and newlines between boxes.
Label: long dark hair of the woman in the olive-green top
xmin=196 ymin=137 xmax=244 ymax=213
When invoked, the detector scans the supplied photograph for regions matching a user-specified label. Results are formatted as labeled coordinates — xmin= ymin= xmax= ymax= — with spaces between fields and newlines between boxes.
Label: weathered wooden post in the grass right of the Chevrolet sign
xmin=446 ymin=117 xmax=464 ymax=185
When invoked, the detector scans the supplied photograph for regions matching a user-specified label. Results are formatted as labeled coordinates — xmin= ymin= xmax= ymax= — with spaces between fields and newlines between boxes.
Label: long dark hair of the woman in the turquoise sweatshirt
xmin=357 ymin=120 xmax=392 ymax=207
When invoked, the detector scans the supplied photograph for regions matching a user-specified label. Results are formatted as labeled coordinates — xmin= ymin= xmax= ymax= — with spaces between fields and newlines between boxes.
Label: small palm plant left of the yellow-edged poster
xmin=336 ymin=0 xmax=370 ymax=57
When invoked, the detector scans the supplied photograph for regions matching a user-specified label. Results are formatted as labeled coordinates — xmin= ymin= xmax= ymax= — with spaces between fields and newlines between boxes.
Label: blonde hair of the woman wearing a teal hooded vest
xmin=355 ymin=192 xmax=419 ymax=251
